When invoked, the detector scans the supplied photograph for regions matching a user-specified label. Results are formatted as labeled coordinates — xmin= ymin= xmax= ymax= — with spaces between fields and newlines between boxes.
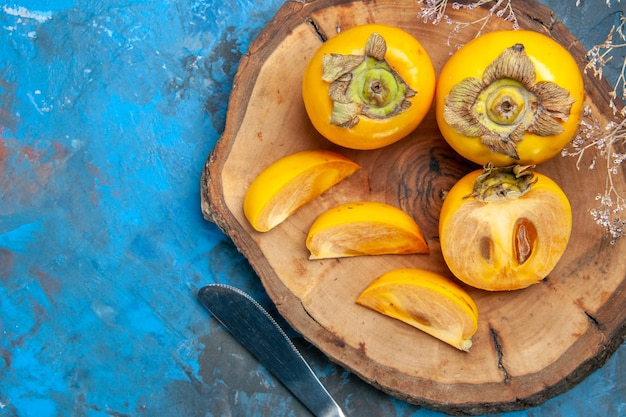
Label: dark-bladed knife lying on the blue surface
xmin=198 ymin=284 xmax=345 ymax=417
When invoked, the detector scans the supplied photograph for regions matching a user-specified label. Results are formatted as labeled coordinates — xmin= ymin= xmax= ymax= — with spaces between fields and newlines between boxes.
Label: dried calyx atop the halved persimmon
xmin=466 ymin=164 xmax=537 ymax=203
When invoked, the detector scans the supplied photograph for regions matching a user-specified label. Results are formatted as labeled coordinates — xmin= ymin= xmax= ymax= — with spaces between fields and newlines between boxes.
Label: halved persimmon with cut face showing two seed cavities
xmin=439 ymin=165 xmax=572 ymax=291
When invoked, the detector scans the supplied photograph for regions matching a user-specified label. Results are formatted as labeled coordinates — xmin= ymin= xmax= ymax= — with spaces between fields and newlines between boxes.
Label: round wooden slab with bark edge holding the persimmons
xmin=201 ymin=0 xmax=626 ymax=414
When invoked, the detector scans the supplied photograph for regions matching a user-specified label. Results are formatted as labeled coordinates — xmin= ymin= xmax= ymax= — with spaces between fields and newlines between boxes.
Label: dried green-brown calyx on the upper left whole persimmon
xmin=322 ymin=33 xmax=416 ymax=128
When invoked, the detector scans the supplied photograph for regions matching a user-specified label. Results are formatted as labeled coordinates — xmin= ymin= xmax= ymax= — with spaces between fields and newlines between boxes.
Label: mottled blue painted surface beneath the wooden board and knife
xmin=0 ymin=0 xmax=626 ymax=417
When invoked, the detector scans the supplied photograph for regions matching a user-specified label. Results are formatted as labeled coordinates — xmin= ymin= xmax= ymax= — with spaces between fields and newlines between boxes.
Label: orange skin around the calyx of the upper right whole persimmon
xmin=435 ymin=30 xmax=585 ymax=166
